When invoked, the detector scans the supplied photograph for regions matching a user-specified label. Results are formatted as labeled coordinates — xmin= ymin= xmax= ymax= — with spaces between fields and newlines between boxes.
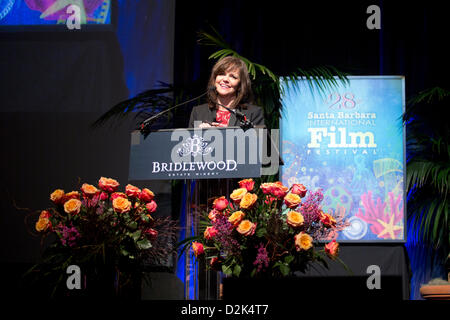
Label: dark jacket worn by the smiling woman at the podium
xmin=189 ymin=103 xmax=264 ymax=128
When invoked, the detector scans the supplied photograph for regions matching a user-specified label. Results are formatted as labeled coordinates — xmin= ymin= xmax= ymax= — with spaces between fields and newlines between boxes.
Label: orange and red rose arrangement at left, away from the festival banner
xmin=25 ymin=177 xmax=177 ymax=296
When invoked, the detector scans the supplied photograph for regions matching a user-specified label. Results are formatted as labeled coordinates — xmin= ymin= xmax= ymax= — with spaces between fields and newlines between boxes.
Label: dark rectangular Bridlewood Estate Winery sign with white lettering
xmin=129 ymin=128 xmax=278 ymax=180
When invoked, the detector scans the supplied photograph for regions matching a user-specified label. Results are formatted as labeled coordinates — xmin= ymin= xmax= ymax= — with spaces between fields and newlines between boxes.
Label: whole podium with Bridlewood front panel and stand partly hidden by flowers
xmin=129 ymin=127 xmax=280 ymax=300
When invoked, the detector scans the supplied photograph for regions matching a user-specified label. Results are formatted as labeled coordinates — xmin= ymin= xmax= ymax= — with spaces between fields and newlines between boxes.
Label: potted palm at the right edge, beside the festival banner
xmin=403 ymin=87 xmax=450 ymax=297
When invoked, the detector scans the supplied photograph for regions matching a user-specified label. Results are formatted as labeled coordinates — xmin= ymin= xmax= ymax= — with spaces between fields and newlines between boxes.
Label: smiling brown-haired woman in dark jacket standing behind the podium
xmin=189 ymin=56 xmax=264 ymax=128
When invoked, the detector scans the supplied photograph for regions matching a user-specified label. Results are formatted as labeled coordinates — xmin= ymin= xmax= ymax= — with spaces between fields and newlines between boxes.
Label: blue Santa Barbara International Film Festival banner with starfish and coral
xmin=280 ymin=76 xmax=406 ymax=242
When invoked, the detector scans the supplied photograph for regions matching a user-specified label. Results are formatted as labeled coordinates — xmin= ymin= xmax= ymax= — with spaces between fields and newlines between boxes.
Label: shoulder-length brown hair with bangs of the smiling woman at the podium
xmin=207 ymin=56 xmax=253 ymax=109
